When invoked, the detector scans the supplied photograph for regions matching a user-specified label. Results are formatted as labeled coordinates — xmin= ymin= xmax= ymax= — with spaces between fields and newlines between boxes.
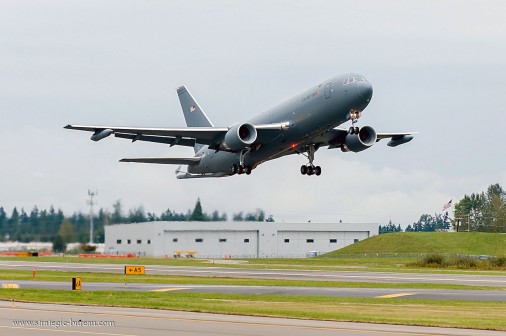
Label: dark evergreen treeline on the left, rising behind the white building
xmin=0 ymin=199 xmax=274 ymax=243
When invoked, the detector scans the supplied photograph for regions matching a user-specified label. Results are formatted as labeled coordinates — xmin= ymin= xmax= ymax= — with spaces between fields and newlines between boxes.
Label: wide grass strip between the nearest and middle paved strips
xmin=0 ymin=289 xmax=506 ymax=330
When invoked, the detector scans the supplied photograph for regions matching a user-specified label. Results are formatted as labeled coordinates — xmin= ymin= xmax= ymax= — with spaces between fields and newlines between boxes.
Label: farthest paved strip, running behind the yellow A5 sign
xmin=0 ymin=260 xmax=506 ymax=287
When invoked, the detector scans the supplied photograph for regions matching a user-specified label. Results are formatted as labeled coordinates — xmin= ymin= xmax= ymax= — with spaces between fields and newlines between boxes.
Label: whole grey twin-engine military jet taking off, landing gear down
xmin=65 ymin=74 xmax=415 ymax=179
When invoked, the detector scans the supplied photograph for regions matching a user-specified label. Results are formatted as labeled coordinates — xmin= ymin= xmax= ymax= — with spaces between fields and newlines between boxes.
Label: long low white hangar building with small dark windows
xmin=104 ymin=222 xmax=378 ymax=258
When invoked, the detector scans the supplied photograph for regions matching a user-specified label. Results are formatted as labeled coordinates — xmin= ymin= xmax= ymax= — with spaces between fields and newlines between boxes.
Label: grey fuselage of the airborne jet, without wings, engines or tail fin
xmin=188 ymin=74 xmax=372 ymax=177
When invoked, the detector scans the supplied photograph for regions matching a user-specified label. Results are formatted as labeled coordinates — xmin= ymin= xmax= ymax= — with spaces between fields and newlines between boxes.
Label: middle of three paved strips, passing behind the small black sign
xmin=0 ymin=277 xmax=506 ymax=302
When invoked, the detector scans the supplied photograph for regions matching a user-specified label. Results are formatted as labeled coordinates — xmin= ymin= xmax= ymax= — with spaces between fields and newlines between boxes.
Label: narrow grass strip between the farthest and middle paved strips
xmin=0 ymin=270 xmax=506 ymax=290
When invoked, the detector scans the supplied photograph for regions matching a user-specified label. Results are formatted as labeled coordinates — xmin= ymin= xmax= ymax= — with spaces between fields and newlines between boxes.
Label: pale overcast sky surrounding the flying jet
xmin=0 ymin=0 xmax=506 ymax=226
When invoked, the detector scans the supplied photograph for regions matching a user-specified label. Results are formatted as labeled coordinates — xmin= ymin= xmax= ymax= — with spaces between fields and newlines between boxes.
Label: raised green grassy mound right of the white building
xmin=322 ymin=232 xmax=506 ymax=258
